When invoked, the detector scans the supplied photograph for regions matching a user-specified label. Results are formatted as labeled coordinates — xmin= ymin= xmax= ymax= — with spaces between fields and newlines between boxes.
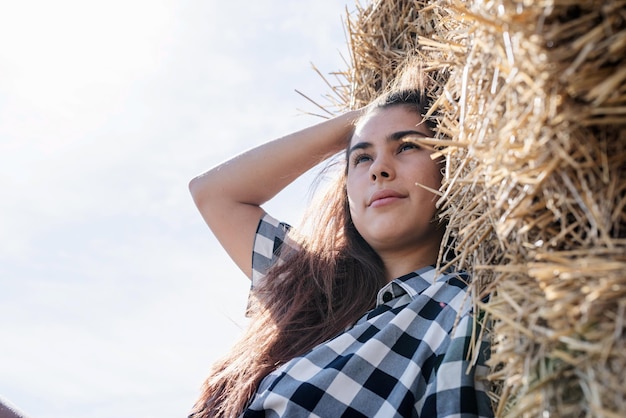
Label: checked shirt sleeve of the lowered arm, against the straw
xmin=420 ymin=314 xmax=493 ymax=418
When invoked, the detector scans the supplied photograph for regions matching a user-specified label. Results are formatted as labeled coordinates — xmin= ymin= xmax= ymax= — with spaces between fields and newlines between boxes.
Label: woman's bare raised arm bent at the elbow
xmin=189 ymin=111 xmax=360 ymax=277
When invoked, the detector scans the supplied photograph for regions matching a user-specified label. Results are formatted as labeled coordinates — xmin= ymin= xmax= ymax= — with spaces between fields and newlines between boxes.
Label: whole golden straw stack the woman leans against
xmin=320 ymin=0 xmax=626 ymax=418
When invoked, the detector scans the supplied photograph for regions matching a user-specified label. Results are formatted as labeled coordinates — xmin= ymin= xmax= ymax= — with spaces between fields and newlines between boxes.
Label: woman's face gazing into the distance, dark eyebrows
xmin=347 ymin=105 xmax=442 ymax=254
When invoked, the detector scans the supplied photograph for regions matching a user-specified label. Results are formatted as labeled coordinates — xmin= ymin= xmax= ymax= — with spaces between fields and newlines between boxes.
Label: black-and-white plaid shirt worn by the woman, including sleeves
xmin=243 ymin=215 xmax=493 ymax=418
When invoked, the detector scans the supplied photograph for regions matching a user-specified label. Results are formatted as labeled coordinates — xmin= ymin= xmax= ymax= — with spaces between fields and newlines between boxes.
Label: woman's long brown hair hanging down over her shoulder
xmin=190 ymin=62 xmax=436 ymax=418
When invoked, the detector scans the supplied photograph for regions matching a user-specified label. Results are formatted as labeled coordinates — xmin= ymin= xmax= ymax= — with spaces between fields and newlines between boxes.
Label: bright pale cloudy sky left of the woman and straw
xmin=0 ymin=0 xmax=352 ymax=418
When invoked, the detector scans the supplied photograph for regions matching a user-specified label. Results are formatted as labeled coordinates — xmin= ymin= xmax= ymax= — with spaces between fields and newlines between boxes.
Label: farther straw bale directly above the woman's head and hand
xmin=307 ymin=0 xmax=458 ymax=114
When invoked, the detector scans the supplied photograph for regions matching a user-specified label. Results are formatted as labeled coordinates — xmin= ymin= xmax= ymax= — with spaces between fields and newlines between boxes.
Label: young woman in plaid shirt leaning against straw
xmin=190 ymin=67 xmax=492 ymax=417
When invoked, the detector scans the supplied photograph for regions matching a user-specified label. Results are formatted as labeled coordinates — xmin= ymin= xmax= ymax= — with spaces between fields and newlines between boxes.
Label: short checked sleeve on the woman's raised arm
xmin=252 ymin=214 xmax=295 ymax=287
